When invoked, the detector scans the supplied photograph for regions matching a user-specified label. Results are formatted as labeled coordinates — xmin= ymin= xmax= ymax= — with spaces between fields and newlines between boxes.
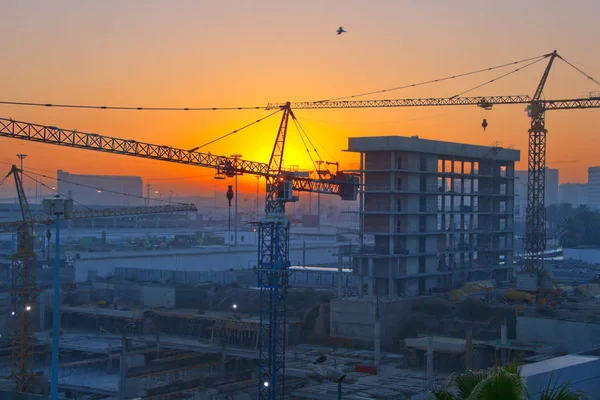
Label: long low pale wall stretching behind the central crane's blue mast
xmin=73 ymin=243 xmax=347 ymax=282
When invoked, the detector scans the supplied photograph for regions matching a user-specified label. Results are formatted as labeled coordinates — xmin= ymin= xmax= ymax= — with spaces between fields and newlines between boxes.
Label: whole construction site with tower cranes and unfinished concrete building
xmin=0 ymin=45 xmax=600 ymax=400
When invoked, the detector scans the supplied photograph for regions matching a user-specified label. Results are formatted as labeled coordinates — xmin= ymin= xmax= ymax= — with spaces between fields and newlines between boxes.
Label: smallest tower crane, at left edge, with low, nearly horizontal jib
xmin=0 ymin=165 xmax=197 ymax=392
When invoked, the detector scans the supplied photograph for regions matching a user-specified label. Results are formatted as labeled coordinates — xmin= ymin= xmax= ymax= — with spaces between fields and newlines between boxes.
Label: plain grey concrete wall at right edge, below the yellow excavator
xmin=517 ymin=317 xmax=600 ymax=353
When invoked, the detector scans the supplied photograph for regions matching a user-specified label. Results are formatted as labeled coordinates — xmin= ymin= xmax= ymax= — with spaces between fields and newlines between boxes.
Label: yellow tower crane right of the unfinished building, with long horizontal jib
xmin=267 ymin=50 xmax=600 ymax=290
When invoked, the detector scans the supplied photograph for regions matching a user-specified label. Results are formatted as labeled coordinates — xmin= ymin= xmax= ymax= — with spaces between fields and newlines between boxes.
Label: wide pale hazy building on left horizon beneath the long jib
xmin=56 ymin=170 xmax=144 ymax=207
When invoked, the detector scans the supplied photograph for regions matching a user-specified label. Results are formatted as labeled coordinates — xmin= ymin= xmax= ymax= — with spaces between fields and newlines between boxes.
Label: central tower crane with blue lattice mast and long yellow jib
xmin=0 ymin=103 xmax=358 ymax=400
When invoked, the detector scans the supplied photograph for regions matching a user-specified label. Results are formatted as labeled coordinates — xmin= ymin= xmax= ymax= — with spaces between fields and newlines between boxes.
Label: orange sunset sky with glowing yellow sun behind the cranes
xmin=0 ymin=0 xmax=600 ymax=200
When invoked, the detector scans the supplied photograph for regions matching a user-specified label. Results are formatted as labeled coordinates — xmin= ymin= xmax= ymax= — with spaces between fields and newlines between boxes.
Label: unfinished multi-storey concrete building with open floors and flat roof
xmin=348 ymin=136 xmax=520 ymax=297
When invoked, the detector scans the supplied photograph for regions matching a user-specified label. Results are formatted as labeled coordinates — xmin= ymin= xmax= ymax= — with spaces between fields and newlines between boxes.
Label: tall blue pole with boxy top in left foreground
xmin=42 ymin=198 xmax=73 ymax=400
